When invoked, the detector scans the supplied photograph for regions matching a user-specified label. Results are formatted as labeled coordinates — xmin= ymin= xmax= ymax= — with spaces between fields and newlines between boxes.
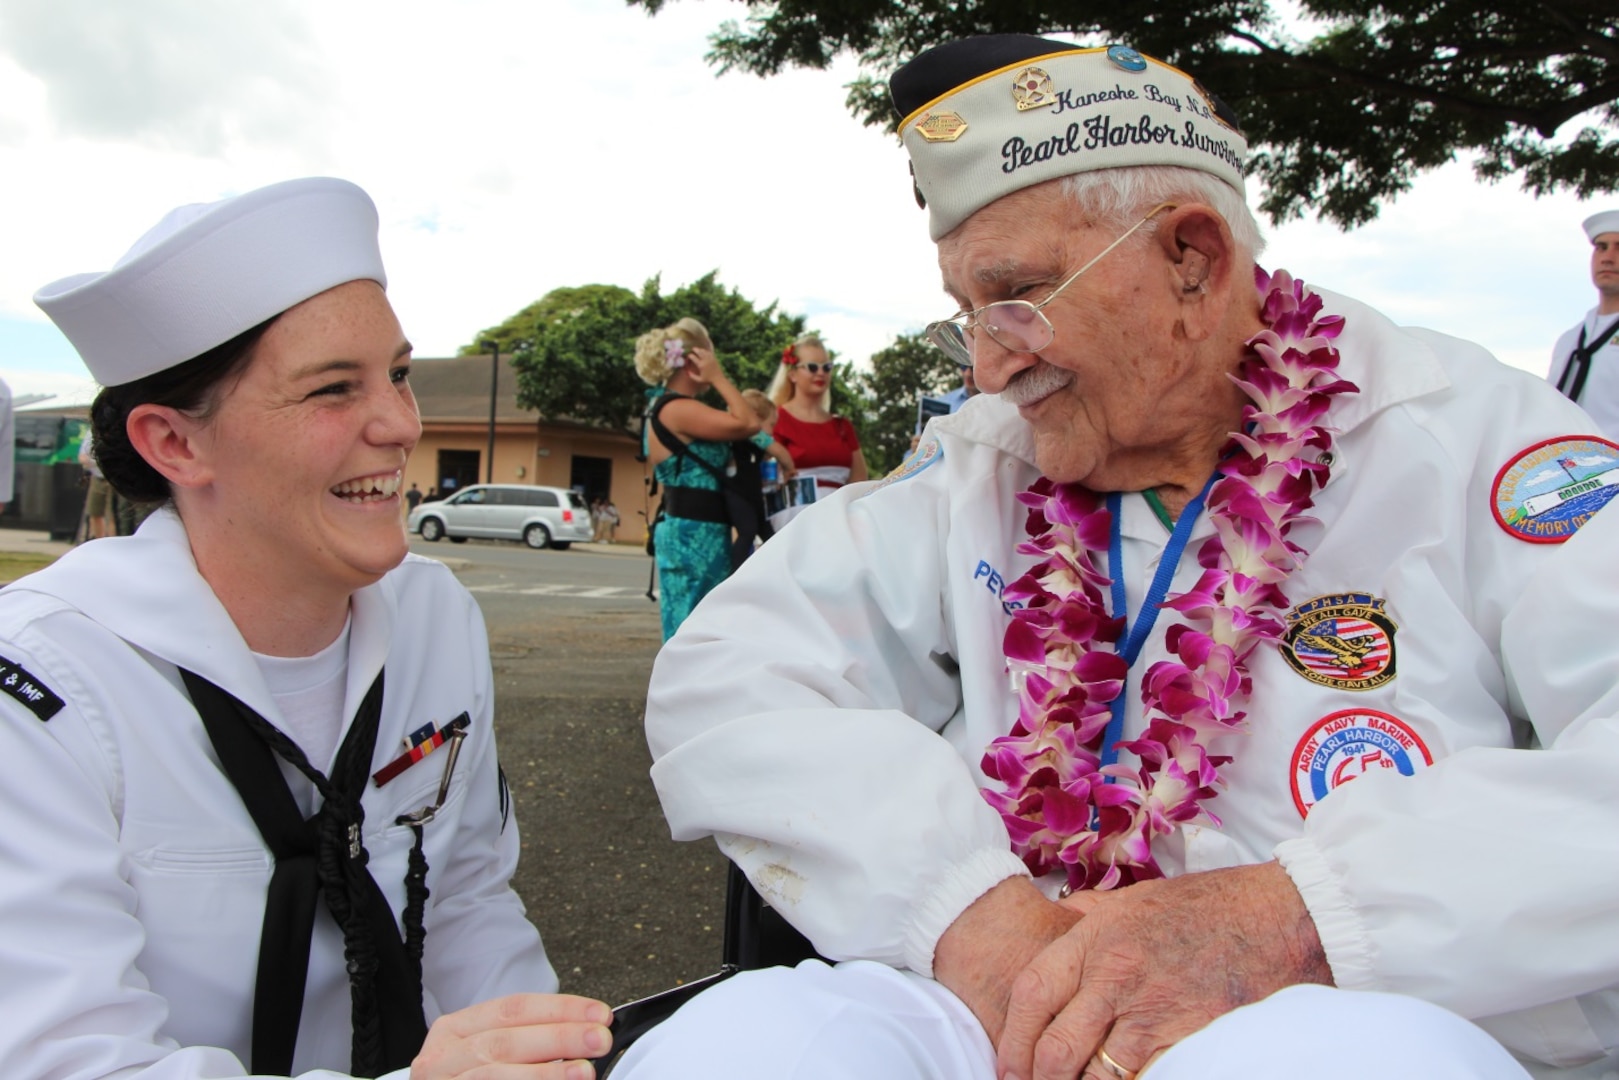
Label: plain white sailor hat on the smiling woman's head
xmin=34 ymin=176 xmax=387 ymax=387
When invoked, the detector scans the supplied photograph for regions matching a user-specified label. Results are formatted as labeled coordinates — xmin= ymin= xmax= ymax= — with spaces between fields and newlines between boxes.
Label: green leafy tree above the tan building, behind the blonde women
xmin=475 ymin=270 xmax=805 ymax=429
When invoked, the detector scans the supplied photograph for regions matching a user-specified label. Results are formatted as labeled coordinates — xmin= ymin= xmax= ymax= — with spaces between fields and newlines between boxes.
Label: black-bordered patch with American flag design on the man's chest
xmin=1282 ymin=593 xmax=1399 ymax=690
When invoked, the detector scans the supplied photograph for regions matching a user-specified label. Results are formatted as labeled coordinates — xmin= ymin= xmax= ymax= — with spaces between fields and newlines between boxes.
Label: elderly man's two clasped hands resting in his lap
xmin=934 ymin=863 xmax=1332 ymax=1080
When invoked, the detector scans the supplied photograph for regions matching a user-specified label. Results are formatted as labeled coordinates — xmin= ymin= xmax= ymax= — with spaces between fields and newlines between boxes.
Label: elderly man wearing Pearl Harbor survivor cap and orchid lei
xmin=611 ymin=37 xmax=1619 ymax=1080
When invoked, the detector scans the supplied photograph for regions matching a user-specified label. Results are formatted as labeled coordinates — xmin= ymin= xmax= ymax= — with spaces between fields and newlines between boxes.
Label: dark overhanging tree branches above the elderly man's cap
xmin=627 ymin=0 xmax=1619 ymax=228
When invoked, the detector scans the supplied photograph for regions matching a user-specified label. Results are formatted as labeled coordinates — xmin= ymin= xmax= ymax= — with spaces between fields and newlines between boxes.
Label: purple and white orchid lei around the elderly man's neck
xmin=983 ymin=269 xmax=1358 ymax=889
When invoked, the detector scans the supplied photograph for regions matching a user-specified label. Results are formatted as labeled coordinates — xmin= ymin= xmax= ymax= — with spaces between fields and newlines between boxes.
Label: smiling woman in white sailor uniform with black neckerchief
xmin=0 ymin=178 xmax=610 ymax=1080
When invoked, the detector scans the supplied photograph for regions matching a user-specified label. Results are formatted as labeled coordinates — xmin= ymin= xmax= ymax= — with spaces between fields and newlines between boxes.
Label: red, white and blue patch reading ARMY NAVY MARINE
xmin=1289 ymin=709 xmax=1433 ymax=818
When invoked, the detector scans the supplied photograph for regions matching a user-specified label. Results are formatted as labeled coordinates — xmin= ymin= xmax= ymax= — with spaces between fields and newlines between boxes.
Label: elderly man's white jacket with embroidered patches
xmin=648 ymin=284 xmax=1619 ymax=1075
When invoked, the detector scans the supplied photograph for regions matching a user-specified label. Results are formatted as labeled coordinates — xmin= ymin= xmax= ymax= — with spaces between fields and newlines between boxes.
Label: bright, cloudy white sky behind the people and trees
xmin=0 ymin=0 xmax=1619 ymax=404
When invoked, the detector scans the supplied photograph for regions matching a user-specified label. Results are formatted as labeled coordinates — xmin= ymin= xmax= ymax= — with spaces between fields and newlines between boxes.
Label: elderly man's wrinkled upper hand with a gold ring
xmin=996 ymin=863 xmax=1332 ymax=1080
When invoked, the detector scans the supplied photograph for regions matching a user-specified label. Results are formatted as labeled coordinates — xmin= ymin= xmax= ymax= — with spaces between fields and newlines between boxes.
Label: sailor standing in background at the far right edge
xmin=1546 ymin=210 xmax=1619 ymax=439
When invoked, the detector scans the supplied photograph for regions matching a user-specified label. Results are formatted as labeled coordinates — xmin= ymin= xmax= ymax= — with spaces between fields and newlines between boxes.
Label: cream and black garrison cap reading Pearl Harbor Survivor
xmin=889 ymin=34 xmax=1248 ymax=240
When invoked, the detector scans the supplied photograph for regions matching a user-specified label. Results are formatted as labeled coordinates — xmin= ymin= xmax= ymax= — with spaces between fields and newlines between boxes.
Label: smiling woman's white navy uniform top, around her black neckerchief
xmin=0 ymin=510 xmax=557 ymax=1080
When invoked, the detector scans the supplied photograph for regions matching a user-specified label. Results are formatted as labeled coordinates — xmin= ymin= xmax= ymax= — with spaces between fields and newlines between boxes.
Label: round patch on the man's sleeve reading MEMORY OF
xmin=1489 ymin=436 xmax=1619 ymax=544
